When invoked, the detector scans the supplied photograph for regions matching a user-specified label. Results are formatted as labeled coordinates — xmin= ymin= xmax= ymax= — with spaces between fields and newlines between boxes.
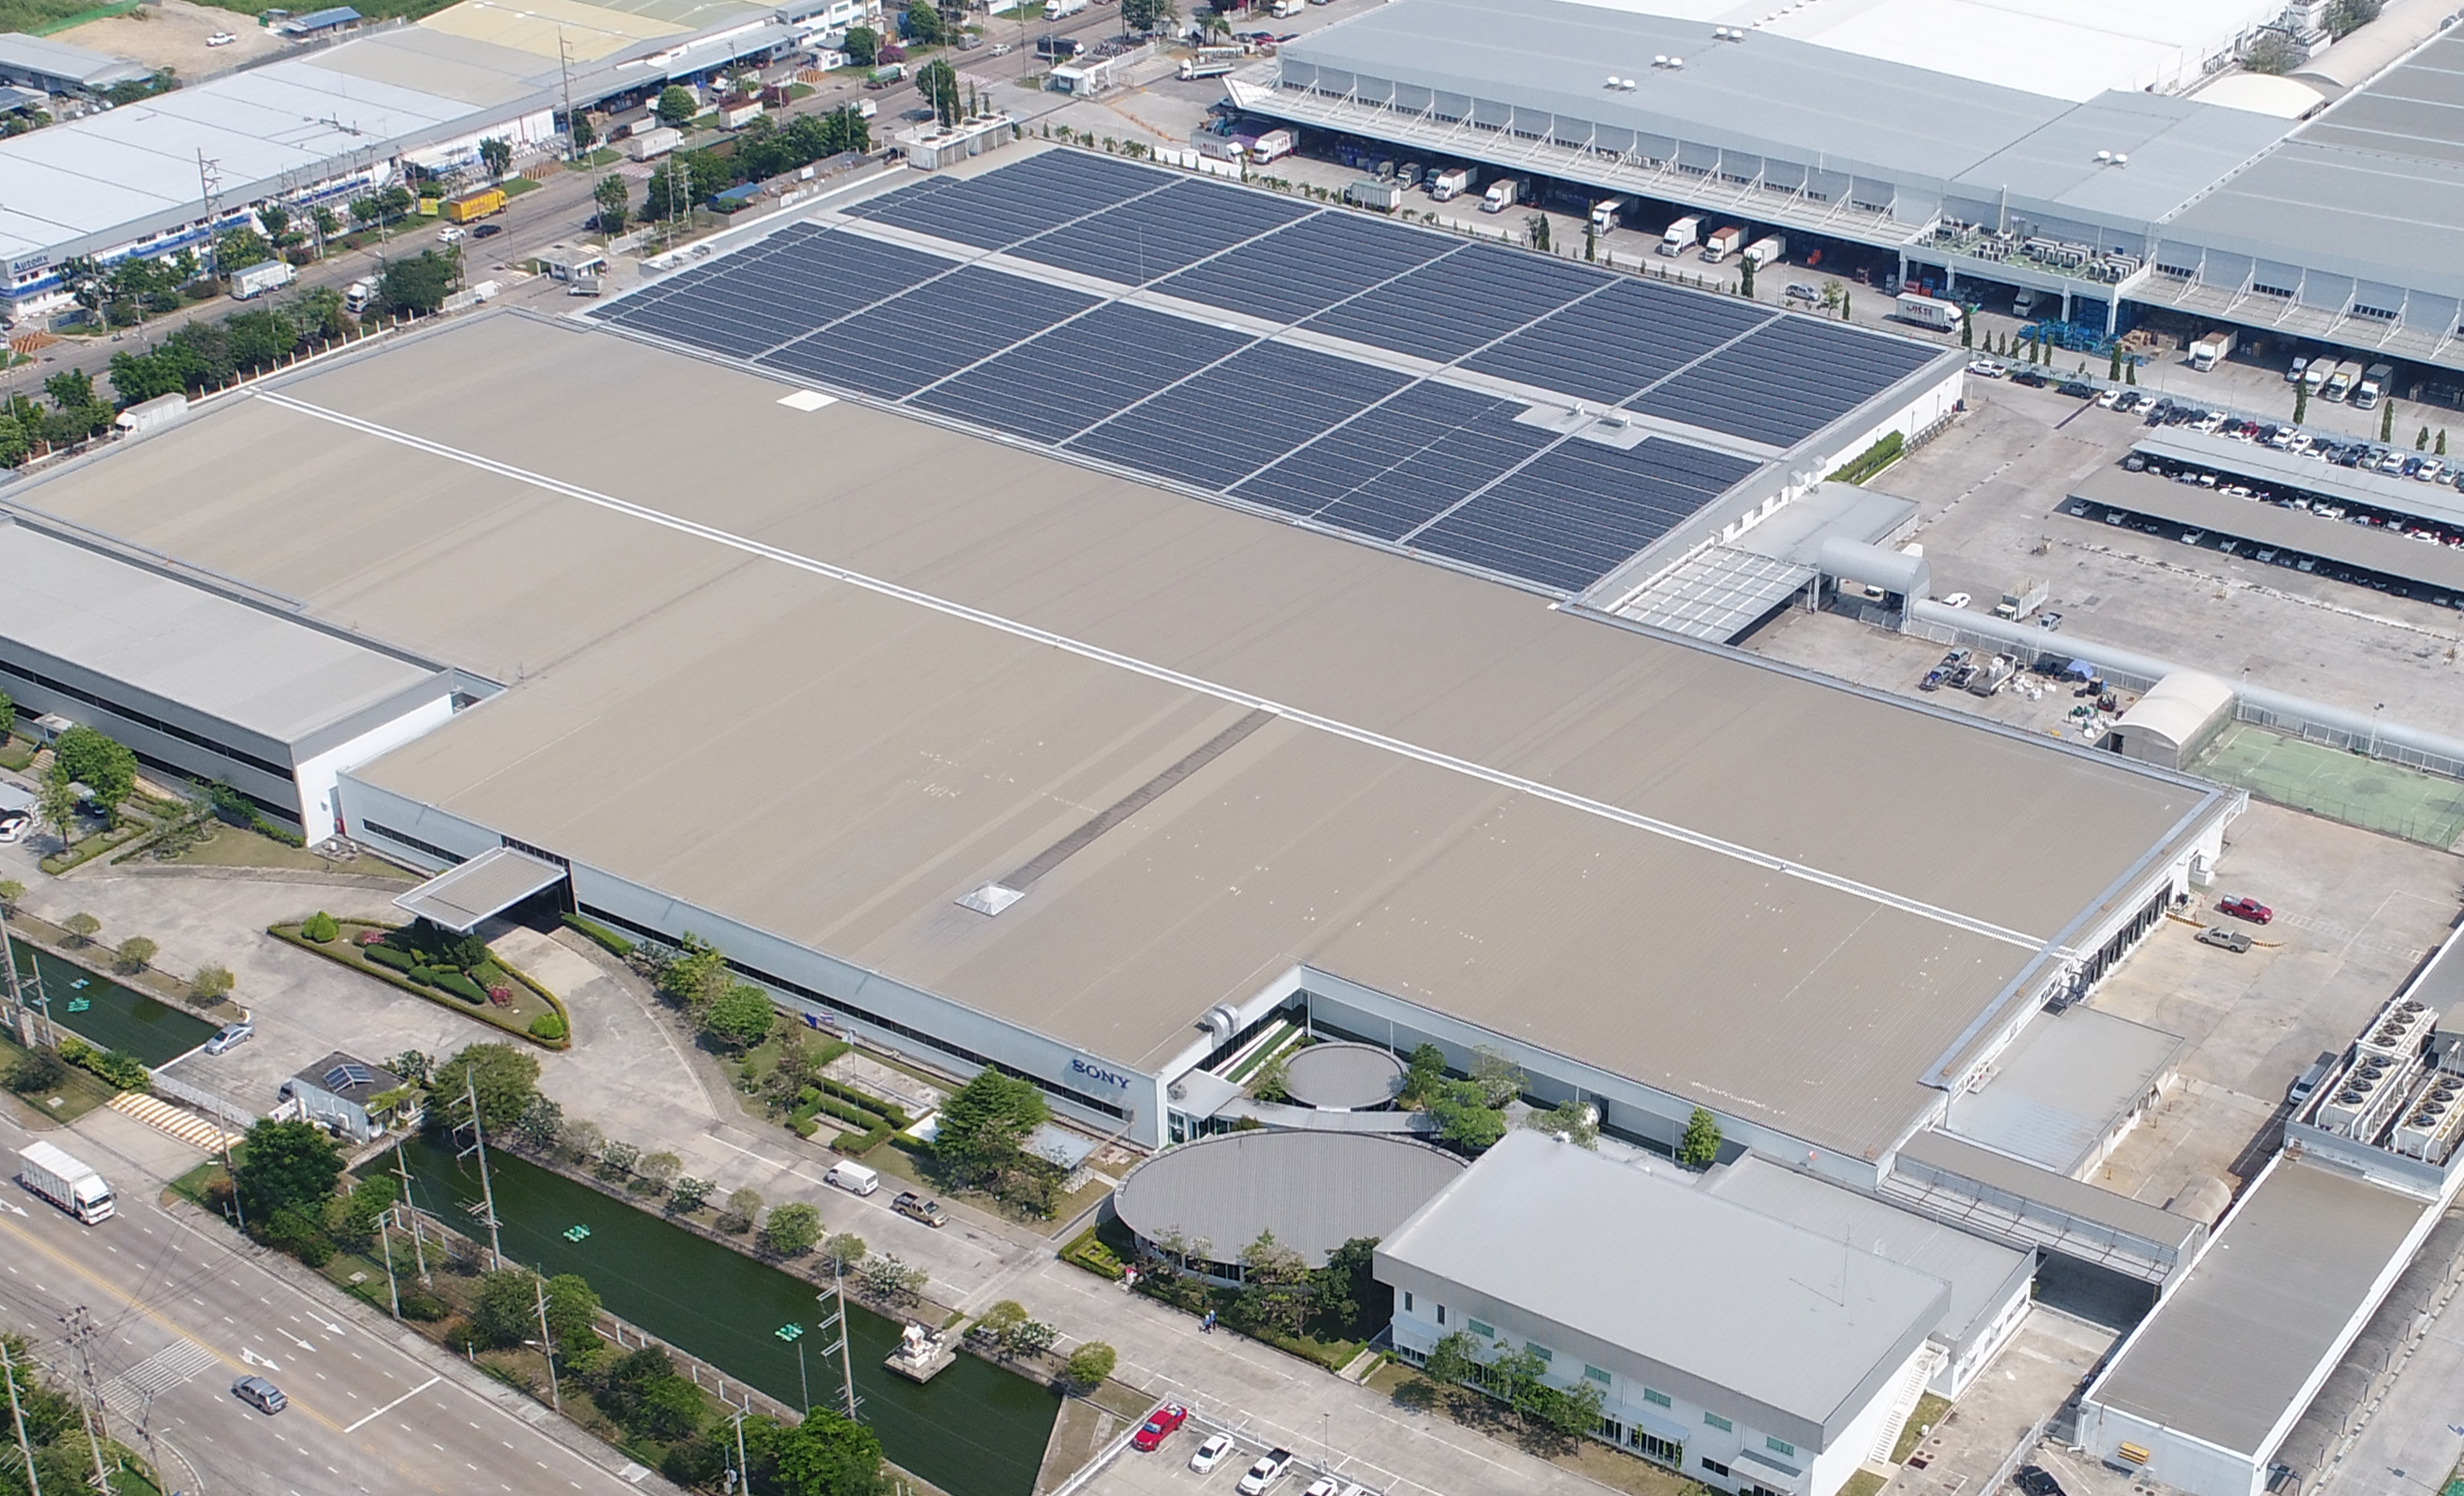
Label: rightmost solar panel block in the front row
xmin=1405 ymin=439 xmax=1756 ymax=591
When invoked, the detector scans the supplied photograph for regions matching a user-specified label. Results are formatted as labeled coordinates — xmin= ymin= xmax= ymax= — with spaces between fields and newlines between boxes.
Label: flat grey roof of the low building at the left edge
xmin=0 ymin=520 xmax=441 ymax=745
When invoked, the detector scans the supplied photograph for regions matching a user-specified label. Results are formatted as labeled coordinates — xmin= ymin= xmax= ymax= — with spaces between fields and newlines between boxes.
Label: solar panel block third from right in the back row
xmin=1308 ymin=244 xmax=1616 ymax=362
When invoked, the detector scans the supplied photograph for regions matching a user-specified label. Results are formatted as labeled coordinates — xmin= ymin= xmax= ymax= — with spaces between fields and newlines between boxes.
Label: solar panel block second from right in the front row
xmin=1232 ymin=384 xmax=1555 ymax=540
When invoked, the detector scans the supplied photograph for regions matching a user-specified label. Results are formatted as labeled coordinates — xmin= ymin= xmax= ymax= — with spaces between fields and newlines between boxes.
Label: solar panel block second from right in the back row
xmin=1464 ymin=281 xmax=1779 ymax=404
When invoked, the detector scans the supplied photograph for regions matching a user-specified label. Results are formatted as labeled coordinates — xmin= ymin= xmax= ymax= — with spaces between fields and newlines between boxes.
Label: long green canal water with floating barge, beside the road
xmin=404 ymin=1141 xmax=1059 ymax=1496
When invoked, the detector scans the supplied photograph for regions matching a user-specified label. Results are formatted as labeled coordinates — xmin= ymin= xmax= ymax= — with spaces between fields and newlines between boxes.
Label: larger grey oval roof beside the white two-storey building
xmin=1111 ymin=1129 xmax=1464 ymax=1267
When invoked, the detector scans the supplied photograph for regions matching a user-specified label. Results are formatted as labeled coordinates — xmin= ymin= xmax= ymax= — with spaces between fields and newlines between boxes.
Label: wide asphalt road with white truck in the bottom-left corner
xmin=0 ymin=1114 xmax=666 ymax=1496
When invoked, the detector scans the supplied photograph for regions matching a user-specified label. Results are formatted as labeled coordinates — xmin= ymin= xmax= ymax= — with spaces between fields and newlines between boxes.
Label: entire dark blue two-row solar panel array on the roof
xmin=591 ymin=151 xmax=1934 ymax=591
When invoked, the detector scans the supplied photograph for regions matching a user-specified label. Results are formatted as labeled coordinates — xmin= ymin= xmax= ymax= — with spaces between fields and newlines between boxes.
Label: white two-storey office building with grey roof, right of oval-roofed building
xmin=1377 ymin=1131 xmax=1961 ymax=1496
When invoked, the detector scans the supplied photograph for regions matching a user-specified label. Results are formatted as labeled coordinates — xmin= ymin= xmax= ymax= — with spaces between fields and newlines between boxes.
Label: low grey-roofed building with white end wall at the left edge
xmin=0 ymin=520 xmax=465 ymax=843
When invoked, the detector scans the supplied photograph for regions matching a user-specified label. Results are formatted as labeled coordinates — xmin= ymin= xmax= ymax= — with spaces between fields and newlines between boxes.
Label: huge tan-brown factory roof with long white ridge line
xmin=12 ymin=316 xmax=2228 ymax=1156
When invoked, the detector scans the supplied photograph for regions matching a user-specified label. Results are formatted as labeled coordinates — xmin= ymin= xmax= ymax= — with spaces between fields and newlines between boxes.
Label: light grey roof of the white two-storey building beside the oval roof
xmin=1377 ymin=1131 xmax=1952 ymax=1442
